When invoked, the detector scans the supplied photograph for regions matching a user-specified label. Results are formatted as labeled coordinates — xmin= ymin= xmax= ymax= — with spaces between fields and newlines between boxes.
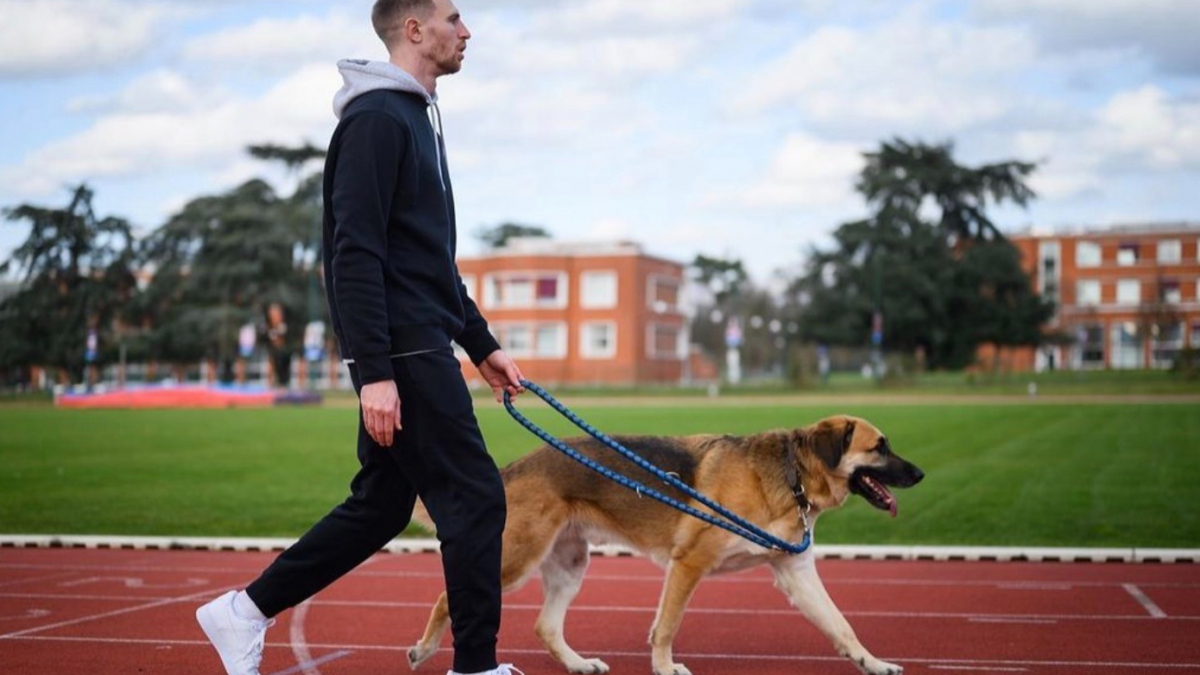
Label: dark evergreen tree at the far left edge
xmin=0 ymin=184 xmax=137 ymax=382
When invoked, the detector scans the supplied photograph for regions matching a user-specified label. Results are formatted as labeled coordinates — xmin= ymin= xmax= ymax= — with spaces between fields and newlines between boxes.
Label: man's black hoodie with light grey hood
xmin=323 ymin=60 xmax=499 ymax=384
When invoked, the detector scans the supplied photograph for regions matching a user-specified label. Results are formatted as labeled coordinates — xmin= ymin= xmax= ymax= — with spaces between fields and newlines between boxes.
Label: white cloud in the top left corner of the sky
xmin=0 ymin=0 xmax=169 ymax=78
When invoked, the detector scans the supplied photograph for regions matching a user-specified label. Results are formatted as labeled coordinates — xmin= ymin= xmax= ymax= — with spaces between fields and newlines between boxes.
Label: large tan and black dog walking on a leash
xmin=408 ymin=416 xmax=924 ymax=675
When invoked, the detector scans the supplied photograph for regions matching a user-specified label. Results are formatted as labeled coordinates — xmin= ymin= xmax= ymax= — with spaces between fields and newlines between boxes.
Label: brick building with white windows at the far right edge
xmin=1010 ymin=223 xmax=1200 ymax=370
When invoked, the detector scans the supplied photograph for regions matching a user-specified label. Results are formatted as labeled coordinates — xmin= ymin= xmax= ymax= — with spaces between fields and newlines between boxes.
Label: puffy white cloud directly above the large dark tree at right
xmin=737 ymin=18 xmax=1036 ymax=138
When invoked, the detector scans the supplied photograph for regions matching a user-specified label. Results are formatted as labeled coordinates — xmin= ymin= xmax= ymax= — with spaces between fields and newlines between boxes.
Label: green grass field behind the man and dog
xmin=0 ymin=396 xmax=1200 ymax=548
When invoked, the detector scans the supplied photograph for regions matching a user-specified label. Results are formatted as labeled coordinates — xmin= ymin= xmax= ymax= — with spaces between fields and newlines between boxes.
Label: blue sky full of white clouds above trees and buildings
xmin=0 ymin=0 xmax=1200 ymax=280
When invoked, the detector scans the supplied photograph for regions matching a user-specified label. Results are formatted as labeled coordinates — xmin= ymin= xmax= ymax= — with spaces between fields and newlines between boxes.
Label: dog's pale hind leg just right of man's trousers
xmin=534 ymin=527 xmax=608 ymax=674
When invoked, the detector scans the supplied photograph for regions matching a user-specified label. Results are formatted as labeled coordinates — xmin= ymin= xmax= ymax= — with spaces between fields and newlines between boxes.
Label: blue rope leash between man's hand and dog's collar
xmin=504 ymin=380 xmax=812 ymax=555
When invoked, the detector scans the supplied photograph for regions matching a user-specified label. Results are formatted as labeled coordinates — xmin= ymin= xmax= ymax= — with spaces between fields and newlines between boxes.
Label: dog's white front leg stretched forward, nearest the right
xmin=772 ymin=551 xmax=904 ymax=675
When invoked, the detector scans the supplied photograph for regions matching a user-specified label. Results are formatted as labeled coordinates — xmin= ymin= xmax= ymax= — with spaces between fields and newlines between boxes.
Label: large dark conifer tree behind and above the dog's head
xmin=790 ymin=141 xmax=1052 ymax=368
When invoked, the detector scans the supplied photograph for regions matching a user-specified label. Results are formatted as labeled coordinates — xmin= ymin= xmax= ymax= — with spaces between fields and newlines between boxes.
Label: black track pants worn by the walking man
xmin=246 ymin=350 xmax=505 ymax=673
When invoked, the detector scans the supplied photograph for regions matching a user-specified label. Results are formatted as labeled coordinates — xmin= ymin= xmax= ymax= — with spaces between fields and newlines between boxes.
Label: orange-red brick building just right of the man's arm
xmin=458 ymin=238 xmax=689 ymax=386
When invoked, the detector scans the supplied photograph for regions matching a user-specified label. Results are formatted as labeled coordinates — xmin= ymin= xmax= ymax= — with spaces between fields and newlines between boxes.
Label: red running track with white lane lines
xmin=0 ymin=549 xmax=1200 ymax=675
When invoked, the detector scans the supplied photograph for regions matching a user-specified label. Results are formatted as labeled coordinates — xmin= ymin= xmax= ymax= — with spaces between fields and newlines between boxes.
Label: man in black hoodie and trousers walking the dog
xmin=197 ymin=0 xmax=523 ymax=675
